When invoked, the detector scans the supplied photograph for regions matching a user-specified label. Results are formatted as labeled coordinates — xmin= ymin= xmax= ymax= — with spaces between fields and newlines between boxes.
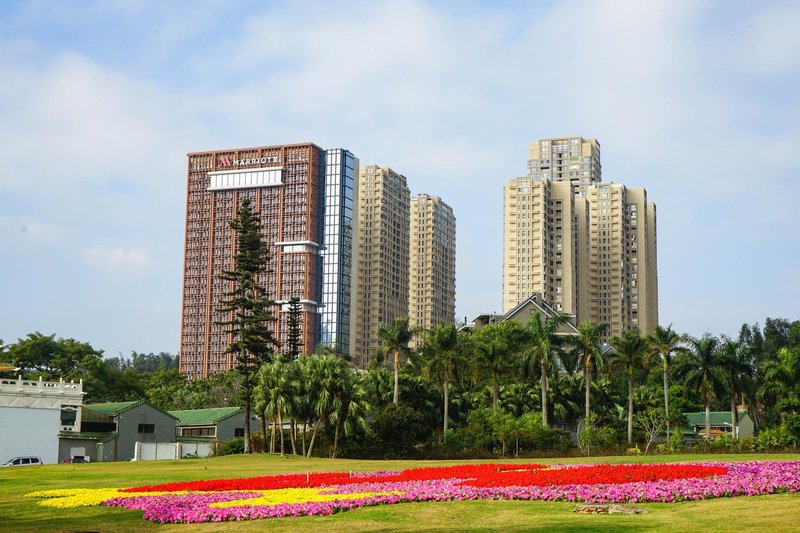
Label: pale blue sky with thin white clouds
xmin=0 ymin=0 xmax=800 ymax=356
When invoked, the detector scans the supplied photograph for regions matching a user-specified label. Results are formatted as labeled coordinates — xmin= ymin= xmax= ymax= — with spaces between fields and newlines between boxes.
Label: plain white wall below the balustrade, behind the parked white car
xmin=0 ymin=407 xmax=61 ymax=464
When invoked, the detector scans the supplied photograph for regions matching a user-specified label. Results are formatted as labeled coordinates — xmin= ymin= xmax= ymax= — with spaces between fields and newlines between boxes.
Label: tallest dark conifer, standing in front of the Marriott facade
xmin=218 ymin=198 xmax=276 ymax=453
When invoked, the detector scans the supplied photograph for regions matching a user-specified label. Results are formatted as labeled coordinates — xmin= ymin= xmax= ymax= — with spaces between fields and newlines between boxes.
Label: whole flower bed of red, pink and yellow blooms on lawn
xmin=23 ymin=462 xmax=800 ymax=523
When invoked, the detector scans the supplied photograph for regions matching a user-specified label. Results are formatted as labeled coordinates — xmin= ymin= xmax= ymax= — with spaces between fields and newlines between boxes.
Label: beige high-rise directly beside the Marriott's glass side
xmin=350 ymin=164 xmax=411 ymax=367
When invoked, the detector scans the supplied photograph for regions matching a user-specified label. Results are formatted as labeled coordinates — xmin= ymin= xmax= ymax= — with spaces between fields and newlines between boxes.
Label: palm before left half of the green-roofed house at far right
xmin=677 ymin=333 xmax=725 ymax=440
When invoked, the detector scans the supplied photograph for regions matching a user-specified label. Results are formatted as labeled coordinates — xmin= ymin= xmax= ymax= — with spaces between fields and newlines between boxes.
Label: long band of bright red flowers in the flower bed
xmin=123 ymin=464 xmax=727 ymax=492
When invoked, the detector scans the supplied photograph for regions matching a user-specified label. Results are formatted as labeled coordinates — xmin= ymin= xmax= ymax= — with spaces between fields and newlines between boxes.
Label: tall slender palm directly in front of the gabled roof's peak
xmin=523 ymin=313 xmax=567 ymax=426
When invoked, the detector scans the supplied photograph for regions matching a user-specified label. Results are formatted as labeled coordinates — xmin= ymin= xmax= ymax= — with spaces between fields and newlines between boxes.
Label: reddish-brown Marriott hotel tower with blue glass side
xmin=180 ymin=143 xmax=358 ymax=378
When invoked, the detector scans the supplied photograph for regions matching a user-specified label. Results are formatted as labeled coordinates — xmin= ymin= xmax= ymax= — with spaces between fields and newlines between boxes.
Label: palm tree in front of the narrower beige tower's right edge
xmin=420 ymin=324 xmax=463 ymax=440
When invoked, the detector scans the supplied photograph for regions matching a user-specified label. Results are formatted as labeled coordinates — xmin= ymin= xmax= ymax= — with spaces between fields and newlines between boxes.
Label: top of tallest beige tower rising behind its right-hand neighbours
xmin=528 ymin=137 xmax=603 ymax=194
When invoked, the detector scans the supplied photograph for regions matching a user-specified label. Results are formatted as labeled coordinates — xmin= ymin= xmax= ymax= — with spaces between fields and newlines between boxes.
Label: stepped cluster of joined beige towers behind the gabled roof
xmin=503 ymin=137 xmax=658 ymax=335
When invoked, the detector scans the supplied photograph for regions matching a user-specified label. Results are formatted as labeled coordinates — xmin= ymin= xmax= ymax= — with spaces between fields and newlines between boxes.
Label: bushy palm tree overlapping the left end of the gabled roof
xmin=468 ymin=320 xmax=524 ymax=412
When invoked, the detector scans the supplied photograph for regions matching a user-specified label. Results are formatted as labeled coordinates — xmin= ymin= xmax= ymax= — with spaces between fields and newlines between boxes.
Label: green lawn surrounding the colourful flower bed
xmin=0 ymin=455 xmax=800 ymax=533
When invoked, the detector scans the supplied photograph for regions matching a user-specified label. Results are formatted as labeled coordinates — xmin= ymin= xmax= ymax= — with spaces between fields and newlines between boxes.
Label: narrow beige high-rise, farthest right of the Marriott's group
xmin=408 ymin=194 xmax=456 ymax=345
